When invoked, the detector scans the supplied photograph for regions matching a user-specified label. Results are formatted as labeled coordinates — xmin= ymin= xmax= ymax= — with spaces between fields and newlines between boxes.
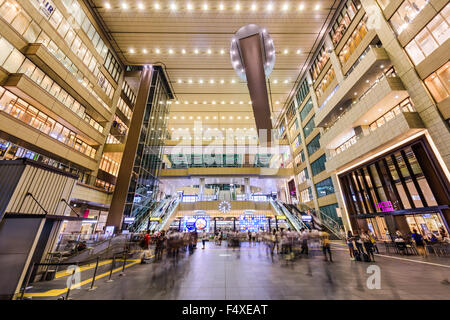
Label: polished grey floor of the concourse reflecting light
xmin=26 ymin=242 xmax=450 ymax=300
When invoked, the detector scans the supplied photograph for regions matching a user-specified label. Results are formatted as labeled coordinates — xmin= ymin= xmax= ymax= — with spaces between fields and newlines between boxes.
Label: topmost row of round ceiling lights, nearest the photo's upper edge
xmin=104 ymin=1 xmax=321 ymax=12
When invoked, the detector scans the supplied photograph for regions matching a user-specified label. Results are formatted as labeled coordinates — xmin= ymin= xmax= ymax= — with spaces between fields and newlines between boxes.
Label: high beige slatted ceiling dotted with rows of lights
xmin=86 ymin=0 xmax=339 ymax=130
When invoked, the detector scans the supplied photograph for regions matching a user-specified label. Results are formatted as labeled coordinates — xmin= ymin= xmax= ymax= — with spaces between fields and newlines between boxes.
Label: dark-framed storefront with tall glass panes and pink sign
xmin=338 ymin=136 xmax=450 ymax=239
